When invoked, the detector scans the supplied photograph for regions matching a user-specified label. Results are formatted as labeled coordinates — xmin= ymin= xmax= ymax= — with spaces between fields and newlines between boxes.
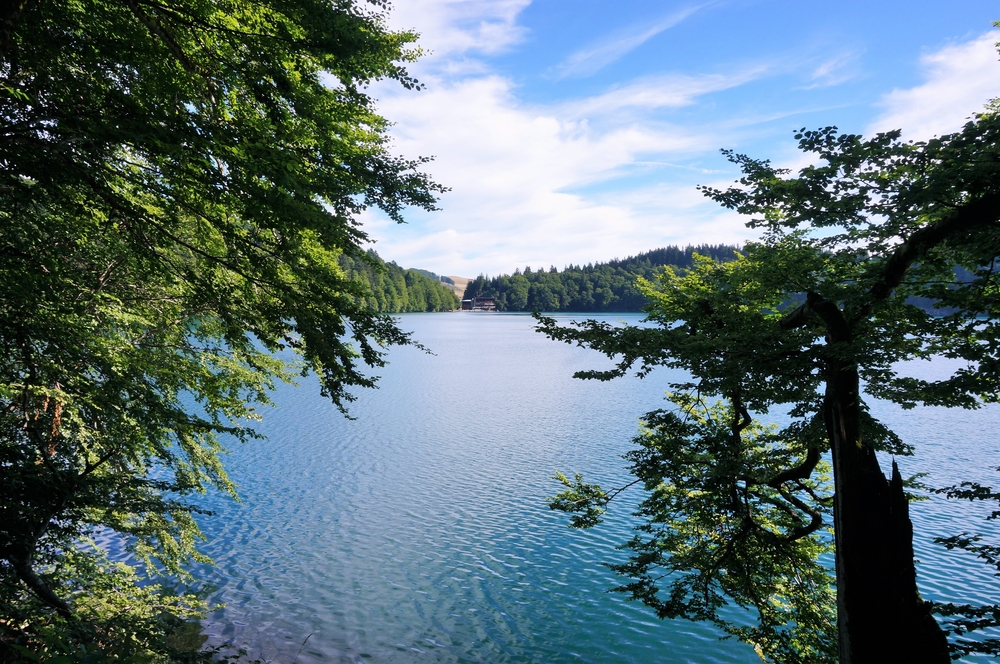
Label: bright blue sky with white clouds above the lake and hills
xmin=362 ymin=0 xmax=1000 ymax=277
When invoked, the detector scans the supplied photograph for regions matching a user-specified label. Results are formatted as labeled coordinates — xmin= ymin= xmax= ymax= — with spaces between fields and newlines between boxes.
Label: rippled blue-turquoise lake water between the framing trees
xmin=186 ymin=313 xmax=1000 ymax=663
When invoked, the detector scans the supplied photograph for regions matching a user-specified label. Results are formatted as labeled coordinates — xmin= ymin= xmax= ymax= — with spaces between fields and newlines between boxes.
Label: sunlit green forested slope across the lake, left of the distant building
xmin=340 ymin=250 xmax=460 ymax=314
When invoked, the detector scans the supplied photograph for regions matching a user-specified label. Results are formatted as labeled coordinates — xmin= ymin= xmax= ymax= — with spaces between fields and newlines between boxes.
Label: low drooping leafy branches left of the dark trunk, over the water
xmin=549 ymin=393 xmax=837 ymax=662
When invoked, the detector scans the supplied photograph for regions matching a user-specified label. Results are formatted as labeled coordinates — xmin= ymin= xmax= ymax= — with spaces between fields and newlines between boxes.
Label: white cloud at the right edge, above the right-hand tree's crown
xmin=868 ymin=31 xmax=1000 ymax=140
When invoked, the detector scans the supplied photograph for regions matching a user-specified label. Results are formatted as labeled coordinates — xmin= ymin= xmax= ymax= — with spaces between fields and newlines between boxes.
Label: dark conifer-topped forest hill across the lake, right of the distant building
xmin=465 ymin=244 xmax=739 ymax=311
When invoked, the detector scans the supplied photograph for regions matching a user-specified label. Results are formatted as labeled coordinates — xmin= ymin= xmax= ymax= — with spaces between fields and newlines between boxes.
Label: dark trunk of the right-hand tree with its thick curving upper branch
xmin=782 ymin=194 xmax=1000 ymax=664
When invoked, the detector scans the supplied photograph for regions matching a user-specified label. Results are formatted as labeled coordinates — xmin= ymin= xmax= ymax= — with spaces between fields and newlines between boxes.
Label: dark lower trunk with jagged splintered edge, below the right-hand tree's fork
xmin=824 ymin=360 xmax=950 ymax=664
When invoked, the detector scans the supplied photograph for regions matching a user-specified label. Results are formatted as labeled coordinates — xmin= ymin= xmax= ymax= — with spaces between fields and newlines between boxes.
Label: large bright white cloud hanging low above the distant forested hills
xmin=365 ymin=76 xmax=746 ymax=276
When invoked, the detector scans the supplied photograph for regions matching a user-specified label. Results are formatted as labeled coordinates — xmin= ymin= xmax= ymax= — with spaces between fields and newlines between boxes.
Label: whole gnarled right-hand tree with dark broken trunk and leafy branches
xmin=539 ymin=101 xmax=1000 ymax=663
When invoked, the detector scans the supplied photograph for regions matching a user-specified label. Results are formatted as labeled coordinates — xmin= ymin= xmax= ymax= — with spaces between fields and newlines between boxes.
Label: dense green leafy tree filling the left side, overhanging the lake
xmin=0 ymin=0 xmax=442 ymax=660
